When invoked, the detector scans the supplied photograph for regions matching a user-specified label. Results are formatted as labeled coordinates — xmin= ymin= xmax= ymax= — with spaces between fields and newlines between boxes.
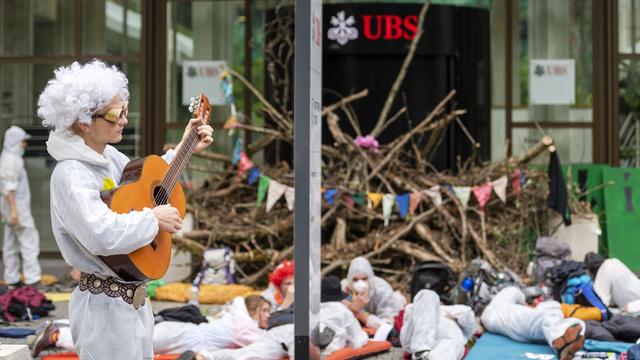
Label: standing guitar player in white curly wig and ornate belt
xmin=38 ymin=60 xmax=213 ymax=360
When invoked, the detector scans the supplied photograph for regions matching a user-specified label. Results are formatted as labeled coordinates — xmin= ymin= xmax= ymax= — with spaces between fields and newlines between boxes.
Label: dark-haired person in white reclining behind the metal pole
xmin=196 ymin=277 xmax=369 ymax=360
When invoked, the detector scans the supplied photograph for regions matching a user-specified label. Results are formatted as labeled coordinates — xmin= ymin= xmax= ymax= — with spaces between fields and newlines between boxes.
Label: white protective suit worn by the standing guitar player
xmin=47 ymin=130 xmax=175 ymax=360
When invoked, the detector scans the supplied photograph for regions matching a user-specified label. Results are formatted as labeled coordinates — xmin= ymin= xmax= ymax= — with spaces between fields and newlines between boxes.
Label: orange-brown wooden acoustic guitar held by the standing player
xmin=100 ymin=94 xmax=211 ymax=281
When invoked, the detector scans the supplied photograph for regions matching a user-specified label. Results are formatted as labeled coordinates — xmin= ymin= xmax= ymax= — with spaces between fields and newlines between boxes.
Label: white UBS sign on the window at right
xmin=529 ymin=59 xmax=576 ymax=105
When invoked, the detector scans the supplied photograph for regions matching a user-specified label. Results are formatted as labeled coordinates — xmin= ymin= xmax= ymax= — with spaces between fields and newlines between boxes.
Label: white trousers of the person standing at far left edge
xmin=2 ymin=222 xmax=41 ymax=285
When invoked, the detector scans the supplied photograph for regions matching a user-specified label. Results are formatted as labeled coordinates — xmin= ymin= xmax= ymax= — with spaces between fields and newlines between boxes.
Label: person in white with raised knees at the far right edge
xmin=584 ymin=252 xmax=640 ymax=312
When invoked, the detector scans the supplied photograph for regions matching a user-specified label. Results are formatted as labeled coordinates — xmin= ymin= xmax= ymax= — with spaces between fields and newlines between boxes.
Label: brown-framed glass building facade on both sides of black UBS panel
xmin=0 ymin=0 xmax=640 ymax=253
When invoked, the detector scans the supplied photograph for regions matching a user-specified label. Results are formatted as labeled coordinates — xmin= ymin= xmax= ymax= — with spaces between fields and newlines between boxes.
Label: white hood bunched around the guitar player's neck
xmin=47 ymin=130 xmax=110 ymax=167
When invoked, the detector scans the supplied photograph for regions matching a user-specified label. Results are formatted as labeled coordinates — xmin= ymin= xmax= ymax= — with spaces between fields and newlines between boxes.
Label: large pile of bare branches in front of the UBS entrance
xmin=174 ymin=1 xmax=553 ymax=286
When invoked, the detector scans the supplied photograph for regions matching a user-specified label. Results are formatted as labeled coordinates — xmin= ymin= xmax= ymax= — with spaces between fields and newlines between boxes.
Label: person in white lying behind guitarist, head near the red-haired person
xmin=33 ymin=295 xmax=271 ymax=357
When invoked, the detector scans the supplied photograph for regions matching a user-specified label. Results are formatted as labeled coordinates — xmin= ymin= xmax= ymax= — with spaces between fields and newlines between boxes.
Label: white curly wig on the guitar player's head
xmin=38 ymin=59 xmax=129 ymax=130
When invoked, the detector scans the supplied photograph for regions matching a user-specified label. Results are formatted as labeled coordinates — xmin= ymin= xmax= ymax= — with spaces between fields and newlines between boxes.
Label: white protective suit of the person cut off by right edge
xmin=593 ymin=258 xmax=640 ymax=309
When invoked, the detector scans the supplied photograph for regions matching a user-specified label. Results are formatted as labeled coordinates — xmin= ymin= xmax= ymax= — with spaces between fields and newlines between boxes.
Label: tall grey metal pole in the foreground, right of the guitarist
xmin=293 ymin=0 xmax=322 ymax=359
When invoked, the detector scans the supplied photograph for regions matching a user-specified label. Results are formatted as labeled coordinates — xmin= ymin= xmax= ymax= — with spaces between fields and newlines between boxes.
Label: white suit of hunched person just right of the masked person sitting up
xmin=400 ymin=290 xmax=476 ymax=360
